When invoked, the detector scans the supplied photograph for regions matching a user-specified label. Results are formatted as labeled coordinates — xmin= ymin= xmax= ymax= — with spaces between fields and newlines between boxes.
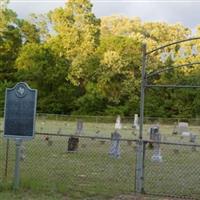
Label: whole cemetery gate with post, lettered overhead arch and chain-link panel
xmin=136 ymin=37 xmax=200 ymax=199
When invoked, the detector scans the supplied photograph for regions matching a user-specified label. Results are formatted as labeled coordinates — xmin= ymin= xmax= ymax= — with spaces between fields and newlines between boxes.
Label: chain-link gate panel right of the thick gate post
xmin=144 ymin=142 xmax=200 ymax=199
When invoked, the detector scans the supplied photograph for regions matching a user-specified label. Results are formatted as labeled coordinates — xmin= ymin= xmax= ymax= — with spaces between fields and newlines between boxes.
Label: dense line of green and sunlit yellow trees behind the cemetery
xmin=0 ymin=0 xmax=200 ymax=117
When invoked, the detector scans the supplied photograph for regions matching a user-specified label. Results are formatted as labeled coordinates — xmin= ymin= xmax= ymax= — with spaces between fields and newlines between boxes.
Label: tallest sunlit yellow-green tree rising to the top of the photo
xmin=50 ymin=0 xmax=100 ymax=87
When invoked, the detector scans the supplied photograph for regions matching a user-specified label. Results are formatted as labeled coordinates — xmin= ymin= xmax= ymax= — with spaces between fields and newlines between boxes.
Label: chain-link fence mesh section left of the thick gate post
xmin=1 ymin=134 xmax=136 ymax=199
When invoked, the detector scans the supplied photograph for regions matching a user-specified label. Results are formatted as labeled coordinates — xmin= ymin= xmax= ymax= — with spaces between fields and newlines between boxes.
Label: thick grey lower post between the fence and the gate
xmin=135 ymin=140 xmax=144 ymax=193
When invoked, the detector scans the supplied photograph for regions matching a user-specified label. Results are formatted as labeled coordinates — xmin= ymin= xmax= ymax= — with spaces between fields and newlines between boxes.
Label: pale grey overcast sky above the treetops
xmin=9 ymin=0 xmax=200 ymax=29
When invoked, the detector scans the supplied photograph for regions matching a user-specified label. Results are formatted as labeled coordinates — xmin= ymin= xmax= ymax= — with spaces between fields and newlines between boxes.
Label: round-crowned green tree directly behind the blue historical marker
xmin=16 ymin=43 xmax=79 ymax=113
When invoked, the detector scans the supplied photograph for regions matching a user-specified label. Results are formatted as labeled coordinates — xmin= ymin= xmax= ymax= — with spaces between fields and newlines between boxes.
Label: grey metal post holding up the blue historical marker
xmin=14 ymin=138 xmax=22 ymax=189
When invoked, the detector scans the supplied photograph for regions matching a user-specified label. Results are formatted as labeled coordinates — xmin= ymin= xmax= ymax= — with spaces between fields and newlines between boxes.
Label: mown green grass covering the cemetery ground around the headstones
xmin=0 ymin=120 xmax=200 ymax=200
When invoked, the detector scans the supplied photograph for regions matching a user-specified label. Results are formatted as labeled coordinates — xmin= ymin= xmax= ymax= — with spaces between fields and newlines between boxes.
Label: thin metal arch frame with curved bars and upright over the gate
xmin=139 ymin=37 xmax=200 ymax=140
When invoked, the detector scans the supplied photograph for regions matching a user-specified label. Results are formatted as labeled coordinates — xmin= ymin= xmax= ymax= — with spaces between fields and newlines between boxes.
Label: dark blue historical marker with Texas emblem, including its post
xmin=4 ymin=82 xmax=37 ymax=189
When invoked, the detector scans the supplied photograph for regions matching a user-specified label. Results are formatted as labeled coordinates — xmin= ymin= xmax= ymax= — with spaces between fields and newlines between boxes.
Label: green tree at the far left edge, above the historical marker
xmin=0 ymin=9 xmax=22 ymax=81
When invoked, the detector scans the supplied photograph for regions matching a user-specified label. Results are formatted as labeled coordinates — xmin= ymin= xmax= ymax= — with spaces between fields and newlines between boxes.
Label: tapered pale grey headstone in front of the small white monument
xmin=109 ymin=130 xmax=121 ymax=158
